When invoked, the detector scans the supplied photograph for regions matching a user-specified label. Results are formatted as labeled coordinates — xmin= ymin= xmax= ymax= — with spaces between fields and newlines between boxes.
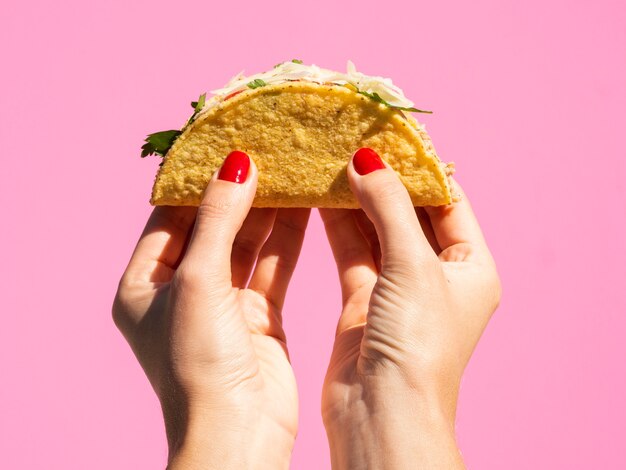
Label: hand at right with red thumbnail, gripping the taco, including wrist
xmin=320 ymin=149 xmax=500 ymax=469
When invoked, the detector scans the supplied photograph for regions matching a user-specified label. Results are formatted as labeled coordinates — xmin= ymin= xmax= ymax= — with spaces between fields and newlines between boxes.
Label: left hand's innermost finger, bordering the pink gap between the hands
xmin=248 ymin=209 xmax=311 ymax=315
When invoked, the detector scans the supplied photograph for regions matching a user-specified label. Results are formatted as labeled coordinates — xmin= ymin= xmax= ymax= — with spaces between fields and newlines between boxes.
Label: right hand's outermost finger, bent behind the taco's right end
xmin=424 ymin=180 xmax=490 ymax=257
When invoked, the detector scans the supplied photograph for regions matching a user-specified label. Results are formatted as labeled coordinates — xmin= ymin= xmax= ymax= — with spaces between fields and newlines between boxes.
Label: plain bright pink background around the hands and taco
xmin=0 ymin=0 xmax=626 ymax=470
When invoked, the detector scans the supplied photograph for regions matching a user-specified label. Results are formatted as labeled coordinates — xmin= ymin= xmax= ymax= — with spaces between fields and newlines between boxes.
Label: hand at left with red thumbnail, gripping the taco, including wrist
xmin=113 ymin=153 xmax=309 ymax=469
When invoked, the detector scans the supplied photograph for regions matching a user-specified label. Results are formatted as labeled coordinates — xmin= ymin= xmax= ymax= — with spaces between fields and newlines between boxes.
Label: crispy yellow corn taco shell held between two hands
xmin=150 ymin=81 xmax=453 ymax=208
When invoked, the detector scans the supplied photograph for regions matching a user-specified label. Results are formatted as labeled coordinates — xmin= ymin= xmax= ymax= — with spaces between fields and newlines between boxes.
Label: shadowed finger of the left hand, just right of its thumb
xmin=230 ymin=207 xmax=276 ymax=288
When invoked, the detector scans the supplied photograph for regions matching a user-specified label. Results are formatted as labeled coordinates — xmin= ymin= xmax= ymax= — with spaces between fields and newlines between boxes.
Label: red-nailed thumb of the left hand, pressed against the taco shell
xmin=179 ymin=151 xmax=257 ymax=288
